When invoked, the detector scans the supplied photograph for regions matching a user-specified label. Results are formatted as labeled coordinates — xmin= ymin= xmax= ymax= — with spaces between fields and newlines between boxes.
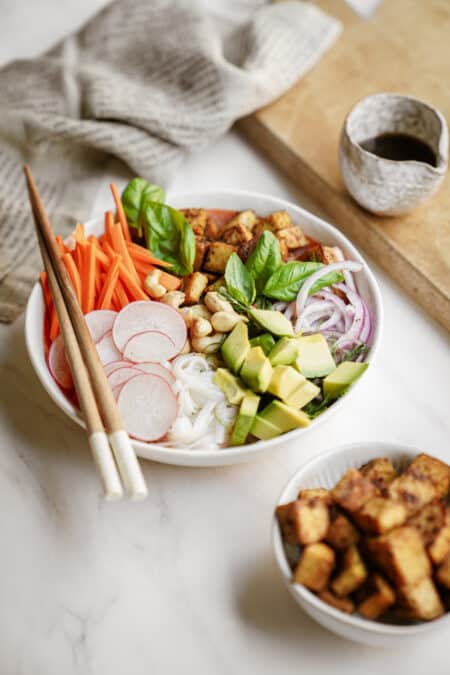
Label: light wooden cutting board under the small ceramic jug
xmin=239 ymin=0 xmax=450 ymax=331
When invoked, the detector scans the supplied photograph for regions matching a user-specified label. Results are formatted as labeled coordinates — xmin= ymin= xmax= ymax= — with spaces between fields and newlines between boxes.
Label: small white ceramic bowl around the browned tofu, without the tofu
xmin=272 ymin=441 xmax=450 ymax=647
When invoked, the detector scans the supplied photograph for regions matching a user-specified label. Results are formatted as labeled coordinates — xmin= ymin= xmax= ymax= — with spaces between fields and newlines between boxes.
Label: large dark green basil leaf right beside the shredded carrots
xmin=142 ymin=197 xmax=195 ymax=276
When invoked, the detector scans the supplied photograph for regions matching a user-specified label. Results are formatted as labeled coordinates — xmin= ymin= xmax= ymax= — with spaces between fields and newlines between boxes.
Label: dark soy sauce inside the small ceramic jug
xmin=360 ymin=134 xmax=437 ymax=166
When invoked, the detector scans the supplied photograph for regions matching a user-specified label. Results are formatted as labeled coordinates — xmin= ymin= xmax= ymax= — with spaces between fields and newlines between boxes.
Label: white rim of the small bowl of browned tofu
xmin=271 ymin=439 xmax=450 ymax=637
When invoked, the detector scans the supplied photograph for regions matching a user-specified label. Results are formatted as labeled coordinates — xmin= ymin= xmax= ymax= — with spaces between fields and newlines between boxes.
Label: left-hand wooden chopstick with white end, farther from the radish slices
xmin=38 ymin=231 xmax=123 ymax=501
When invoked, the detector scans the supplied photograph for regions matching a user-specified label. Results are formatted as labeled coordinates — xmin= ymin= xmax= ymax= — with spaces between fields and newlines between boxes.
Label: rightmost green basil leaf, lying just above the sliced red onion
xmin=263 ymin=262 xmax=342 ymax=302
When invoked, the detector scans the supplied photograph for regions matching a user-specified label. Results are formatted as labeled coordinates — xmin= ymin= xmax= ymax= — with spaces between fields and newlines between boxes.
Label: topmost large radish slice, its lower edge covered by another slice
xmin=112 ymin=300 xmax=187 ymax=354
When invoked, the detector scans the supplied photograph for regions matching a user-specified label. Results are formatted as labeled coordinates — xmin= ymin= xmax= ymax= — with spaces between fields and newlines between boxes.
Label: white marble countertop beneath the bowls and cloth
xmin=0 ymin=0 xmax=450 ymax=675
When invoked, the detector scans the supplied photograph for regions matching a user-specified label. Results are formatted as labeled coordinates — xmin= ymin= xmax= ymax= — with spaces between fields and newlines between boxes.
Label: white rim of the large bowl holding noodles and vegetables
xmin=24 ymin=189 xmax=384 ymax=466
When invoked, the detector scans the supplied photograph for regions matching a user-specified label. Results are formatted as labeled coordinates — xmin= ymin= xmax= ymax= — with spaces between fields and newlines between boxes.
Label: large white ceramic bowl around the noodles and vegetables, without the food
xmin=25 ymin=191 xmax=383 ymax=466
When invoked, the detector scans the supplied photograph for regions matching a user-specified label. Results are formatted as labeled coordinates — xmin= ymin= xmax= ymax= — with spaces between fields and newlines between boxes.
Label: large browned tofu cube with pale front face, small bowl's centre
xmin=367 ymin=525 xmax=431 ymax=586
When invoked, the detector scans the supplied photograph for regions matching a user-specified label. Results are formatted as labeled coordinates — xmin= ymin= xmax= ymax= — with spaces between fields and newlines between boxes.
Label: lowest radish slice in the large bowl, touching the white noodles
xmin=117 ymin=373 xmax=177 ymax=442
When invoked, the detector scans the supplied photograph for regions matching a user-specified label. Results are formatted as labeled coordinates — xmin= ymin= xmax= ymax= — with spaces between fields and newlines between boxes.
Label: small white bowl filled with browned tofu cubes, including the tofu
xmin=272 ymin=442 xmax=450 ymax=647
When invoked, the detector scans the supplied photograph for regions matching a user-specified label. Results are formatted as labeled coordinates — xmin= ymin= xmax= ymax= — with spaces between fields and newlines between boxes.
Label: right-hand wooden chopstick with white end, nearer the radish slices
xmin=24 ymin=166 xmax=147 ymax=499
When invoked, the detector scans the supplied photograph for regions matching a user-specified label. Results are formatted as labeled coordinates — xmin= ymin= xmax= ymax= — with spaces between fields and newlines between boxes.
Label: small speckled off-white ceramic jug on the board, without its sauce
xmin=339 ymin=94 xmax=448 ymax=216
